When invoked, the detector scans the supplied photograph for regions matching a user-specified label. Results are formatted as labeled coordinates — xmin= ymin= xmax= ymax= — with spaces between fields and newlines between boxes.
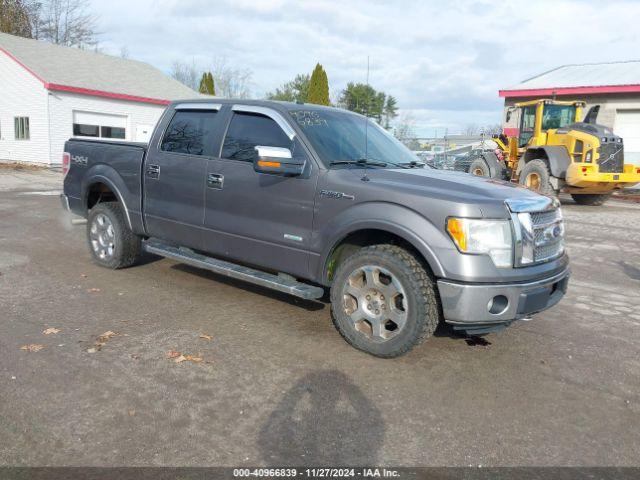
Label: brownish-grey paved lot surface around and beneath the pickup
xmin=0 ymin=170 xmax=640 ymax=466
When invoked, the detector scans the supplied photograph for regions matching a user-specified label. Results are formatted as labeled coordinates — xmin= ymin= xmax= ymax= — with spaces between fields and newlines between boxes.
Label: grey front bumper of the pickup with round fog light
xmin=438 ymin=268 xmax=570 ymax=328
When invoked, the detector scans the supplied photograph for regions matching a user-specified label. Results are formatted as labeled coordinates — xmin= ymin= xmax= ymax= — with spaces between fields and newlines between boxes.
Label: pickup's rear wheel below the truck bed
xmin=87 ymin=202 xmax=142 ymax=269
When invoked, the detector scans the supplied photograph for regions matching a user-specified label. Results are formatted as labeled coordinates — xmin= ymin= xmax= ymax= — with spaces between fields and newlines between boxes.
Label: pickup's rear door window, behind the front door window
xmin=160 ymin=110 xmax=218 ymax=156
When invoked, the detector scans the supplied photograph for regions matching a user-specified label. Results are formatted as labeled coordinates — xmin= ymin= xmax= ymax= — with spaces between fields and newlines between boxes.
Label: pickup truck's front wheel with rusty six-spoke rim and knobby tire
xmin=331 ymin=245 xmax=440 ymax=358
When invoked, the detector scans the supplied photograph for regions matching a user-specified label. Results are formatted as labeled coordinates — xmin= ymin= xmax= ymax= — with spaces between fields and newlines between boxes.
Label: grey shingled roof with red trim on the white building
xmin=0 ymin=33 xmax=199 ymax=105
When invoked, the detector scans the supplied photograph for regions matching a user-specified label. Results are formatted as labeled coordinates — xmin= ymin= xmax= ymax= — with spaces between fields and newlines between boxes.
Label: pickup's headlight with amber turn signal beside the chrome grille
xmin=447 ymin=218 xmax=513 ymax=268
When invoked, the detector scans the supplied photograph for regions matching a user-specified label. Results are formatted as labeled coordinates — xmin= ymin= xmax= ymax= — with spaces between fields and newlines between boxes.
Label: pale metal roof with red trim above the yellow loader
xmin=499 ymin=61 xmax=640 ymax=97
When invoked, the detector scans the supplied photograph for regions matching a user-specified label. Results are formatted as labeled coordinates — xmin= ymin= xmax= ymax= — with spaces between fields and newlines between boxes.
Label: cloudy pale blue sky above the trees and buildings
xmin=90 ymin=0 xmax=640 ymax=136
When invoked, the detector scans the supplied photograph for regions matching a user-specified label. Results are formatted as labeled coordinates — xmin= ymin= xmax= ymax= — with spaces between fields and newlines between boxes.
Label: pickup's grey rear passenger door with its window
xmin=143 ymin=103 xmax=220 ymax=249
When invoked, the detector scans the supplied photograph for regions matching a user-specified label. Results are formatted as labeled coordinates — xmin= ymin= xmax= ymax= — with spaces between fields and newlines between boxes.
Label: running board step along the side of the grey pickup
xmin=144 ymin=241 xmax=324 ymax=300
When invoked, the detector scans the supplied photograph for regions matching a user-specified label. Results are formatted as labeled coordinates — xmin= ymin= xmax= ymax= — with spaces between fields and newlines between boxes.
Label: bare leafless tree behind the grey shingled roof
xmin=35 ymin=0 xmax=98 ymax=48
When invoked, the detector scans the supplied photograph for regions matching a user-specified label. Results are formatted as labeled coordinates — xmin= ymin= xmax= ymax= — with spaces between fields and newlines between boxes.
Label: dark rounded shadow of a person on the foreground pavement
xmin=258 ymin=370 xmax=385 ymax=466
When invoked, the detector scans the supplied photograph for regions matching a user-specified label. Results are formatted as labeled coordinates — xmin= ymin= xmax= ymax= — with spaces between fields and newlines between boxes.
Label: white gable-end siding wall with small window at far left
xmin=0 ymin=51 xmax=50 ymax=164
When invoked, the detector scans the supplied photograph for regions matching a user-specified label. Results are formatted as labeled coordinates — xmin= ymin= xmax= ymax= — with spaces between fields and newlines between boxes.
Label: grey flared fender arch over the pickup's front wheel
xmin=316 ymin=202 xmax=446 ymax=285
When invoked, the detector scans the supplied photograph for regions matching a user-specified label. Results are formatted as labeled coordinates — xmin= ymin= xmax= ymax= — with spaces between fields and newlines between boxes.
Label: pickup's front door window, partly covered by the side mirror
xmin=222 ymin=112 xmax=292 ymax=162
